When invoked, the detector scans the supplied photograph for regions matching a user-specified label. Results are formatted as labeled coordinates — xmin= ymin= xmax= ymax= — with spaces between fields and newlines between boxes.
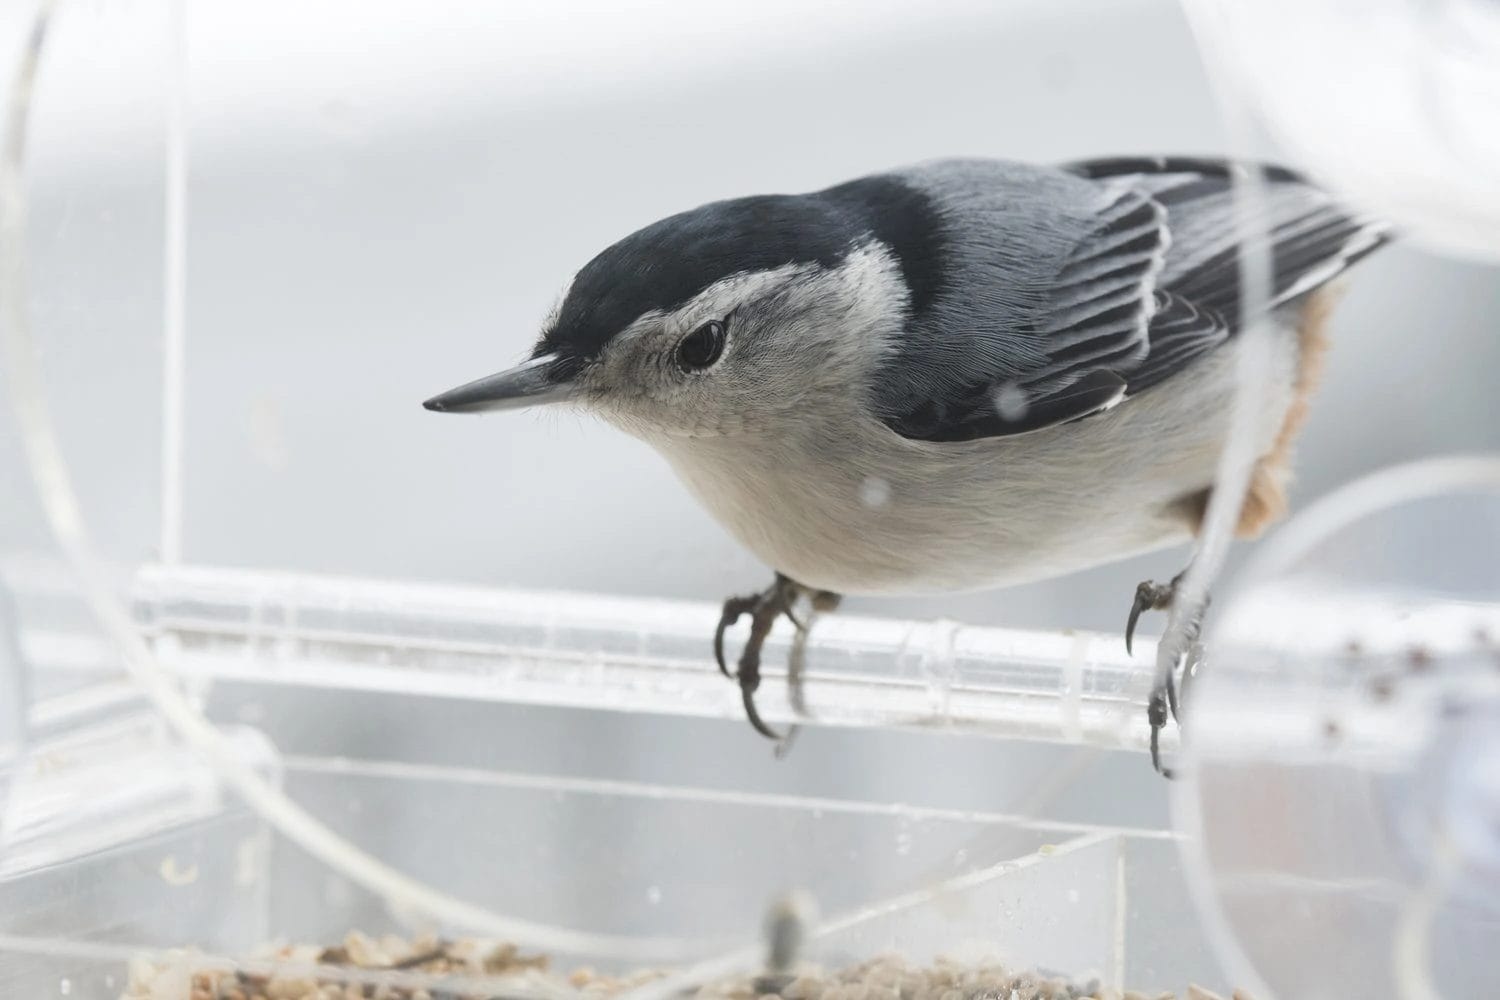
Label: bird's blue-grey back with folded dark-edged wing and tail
xmin=876 ymin=157 xmax=1385 ymax=441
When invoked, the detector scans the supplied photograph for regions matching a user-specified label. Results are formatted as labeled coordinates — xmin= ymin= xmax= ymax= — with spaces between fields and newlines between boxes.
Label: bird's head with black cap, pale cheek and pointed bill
xmin=426 ymin=189 xmax=911 ymax=438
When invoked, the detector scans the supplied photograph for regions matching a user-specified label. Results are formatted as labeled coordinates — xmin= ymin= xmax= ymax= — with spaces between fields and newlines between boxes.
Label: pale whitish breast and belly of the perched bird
xmin=639 ymin=333 xmax=1296 ymax=594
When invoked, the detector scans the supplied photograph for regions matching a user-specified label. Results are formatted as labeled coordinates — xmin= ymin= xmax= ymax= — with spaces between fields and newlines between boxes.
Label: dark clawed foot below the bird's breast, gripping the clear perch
xmin=714 ymin=573 xmax=839 ymax=748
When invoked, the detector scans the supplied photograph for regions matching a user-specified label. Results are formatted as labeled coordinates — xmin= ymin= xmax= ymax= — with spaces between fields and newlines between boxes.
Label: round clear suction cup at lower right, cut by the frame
xmin=1178 ymin=459 xmax=1500 ymax=1000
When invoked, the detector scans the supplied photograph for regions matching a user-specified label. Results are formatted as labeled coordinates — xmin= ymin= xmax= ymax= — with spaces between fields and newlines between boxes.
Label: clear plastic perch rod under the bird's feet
xmin=134 ymin=565 xmax=1173 ymax=750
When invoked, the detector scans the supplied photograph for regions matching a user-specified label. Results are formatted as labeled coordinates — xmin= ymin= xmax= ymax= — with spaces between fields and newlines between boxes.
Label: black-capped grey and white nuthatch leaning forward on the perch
xmin=425 ymin=156 xmax=1391 ymax=774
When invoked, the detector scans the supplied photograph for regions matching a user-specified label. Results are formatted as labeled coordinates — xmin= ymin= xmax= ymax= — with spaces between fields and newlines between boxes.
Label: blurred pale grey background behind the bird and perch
xmin=0 ymin=0 xmax=1500 ymax=822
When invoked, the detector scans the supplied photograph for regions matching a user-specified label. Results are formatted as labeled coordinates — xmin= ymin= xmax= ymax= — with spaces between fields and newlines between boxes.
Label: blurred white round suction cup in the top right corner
xmin=1190 ymin=0 xmax=1500 ymax=261
